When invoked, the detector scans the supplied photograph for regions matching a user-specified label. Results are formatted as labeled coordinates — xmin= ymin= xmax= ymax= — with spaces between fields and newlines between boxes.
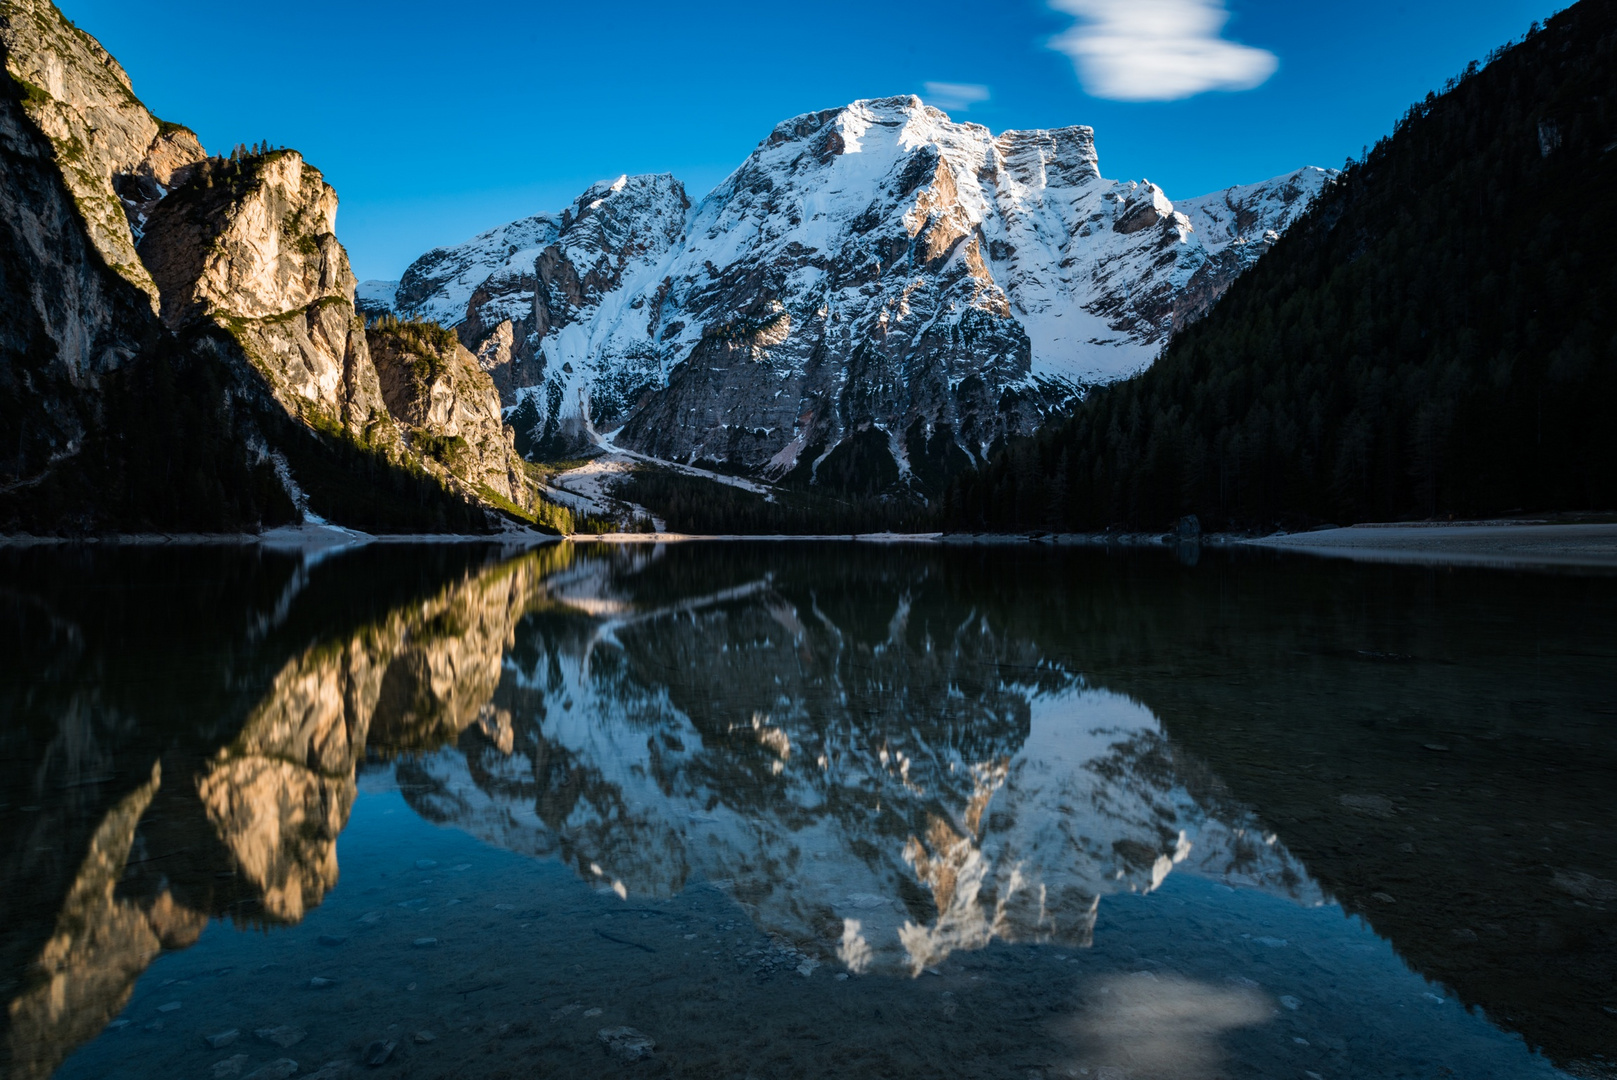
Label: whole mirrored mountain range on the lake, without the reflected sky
xmin=0 ymin=545 xmax=1617 ymax=1078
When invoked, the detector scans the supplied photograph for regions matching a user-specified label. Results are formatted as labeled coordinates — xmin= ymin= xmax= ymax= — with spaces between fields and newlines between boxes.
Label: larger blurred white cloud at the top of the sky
xmin=1049 ymin=0 xmax=1281 ymax=102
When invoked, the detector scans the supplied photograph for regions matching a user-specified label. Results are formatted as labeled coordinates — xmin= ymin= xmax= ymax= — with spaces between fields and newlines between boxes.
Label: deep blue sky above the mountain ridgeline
xmin=61 ymin=0 xmax=1565 ymax=278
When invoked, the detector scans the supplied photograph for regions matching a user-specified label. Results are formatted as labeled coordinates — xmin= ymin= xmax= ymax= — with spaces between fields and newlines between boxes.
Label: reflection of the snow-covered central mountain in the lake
xmin=398 ymin=548 xmax=1319 ymax=973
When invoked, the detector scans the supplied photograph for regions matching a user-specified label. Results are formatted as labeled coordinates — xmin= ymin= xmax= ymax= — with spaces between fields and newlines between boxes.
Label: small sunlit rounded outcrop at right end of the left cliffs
xmin=365 ymin=319 xmax=532 ymax=508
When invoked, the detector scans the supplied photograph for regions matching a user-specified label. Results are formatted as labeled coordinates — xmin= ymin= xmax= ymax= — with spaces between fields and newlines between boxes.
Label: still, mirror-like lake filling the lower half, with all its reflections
xmin=0 ymin=543 xmax=1617 ymax=1080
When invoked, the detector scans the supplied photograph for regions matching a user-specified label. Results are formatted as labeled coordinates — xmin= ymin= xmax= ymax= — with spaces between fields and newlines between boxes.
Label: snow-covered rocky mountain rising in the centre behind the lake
xmin=371 ymin=97 xmax=1331 ymax=491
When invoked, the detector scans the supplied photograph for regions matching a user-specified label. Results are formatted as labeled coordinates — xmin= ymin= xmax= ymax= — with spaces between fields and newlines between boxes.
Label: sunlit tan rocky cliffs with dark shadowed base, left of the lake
xmin=0 ymin=0 xmax=556 ymax=532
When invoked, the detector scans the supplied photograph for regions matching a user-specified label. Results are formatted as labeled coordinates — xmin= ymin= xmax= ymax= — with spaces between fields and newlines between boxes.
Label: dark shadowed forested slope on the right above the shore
xmin=946 ymin=0 xmax=1617 ymax=530
